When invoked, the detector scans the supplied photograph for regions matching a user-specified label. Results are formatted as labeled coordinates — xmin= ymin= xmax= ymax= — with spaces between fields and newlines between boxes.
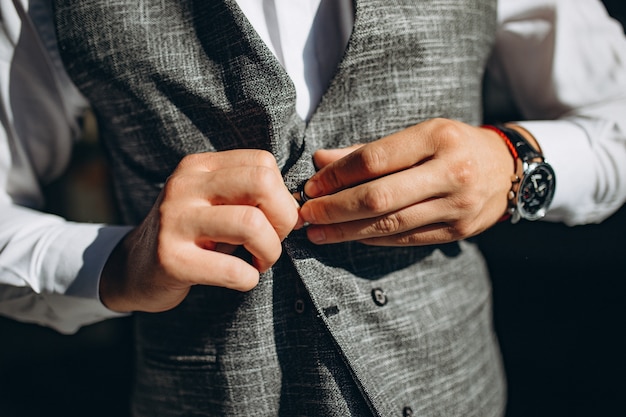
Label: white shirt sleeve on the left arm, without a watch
xmin=0 ymin=2 xmax=129 ymax=333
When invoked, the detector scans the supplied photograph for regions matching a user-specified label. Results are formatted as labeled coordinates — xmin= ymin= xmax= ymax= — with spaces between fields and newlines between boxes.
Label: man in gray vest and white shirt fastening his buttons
xmin=2 ymin=1 xmax=626 ymax=415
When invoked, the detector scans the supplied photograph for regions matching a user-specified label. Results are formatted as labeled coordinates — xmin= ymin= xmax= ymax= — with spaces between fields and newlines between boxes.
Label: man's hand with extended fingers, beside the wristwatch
xmin=300 ymin=119 xmax=514 ymax=246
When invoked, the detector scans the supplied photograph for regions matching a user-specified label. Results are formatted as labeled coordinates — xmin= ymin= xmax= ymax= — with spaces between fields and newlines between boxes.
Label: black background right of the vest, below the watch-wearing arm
xmin=478 ymin=0 xmax=626 ymax=417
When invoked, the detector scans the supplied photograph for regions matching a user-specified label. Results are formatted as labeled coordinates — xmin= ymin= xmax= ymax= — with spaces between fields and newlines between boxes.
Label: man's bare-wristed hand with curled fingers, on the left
xmin=100 ymin=150 xmax=298 ymax=312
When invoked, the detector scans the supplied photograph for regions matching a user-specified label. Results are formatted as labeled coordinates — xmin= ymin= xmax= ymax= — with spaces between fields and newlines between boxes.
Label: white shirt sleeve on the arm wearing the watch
xmin=488 ymin=0 xmax=626 ymax=225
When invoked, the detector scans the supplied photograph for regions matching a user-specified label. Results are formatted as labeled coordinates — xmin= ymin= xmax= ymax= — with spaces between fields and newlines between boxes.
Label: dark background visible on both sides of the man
xmin=0 ymin=0 xmax=626 ymax=417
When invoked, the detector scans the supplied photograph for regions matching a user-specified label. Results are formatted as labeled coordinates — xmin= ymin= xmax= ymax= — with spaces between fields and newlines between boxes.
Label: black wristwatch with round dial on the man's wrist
xmin=493 ymin=125 xmax=556 ymax=223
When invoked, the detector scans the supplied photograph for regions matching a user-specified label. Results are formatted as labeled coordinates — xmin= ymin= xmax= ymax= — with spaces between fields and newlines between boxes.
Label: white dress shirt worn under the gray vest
xmin=0 ymin=0 xmax=626 ymax=333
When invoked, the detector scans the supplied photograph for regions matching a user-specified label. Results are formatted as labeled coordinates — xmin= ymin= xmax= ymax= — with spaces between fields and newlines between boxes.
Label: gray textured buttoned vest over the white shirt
xmin=55 ymin=0 xmax=504 ymax=417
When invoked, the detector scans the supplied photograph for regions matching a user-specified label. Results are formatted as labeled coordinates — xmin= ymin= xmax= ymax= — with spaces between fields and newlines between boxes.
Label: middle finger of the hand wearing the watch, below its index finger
xmin=300 ymin=160 xmax=453 ymax=224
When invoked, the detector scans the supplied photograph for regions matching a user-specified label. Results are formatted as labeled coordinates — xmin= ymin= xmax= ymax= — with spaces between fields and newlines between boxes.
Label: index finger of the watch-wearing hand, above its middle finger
xmin=304 ymin=129 xmax=434 ymax=197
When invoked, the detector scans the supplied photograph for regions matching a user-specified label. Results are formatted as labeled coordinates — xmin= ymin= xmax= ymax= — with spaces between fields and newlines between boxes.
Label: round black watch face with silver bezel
xmin=517 ymin=163 xmax=555 ymax=220
